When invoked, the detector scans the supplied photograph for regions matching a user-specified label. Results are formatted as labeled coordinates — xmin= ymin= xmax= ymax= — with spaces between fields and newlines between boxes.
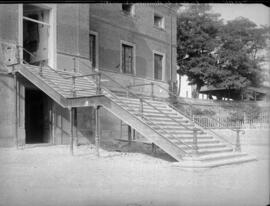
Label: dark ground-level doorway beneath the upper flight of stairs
xmin=25 ymin=89 xmax=50 ymax=144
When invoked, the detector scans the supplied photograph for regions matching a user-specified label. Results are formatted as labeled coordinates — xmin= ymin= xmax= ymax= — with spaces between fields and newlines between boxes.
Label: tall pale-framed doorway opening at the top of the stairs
xmin=21 ymin=4 xmax=56 ymax=67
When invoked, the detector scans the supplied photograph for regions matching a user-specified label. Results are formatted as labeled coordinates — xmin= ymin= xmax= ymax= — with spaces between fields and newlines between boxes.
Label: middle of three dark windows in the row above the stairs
xmin=121 ymin=44 xmax=135 ymax=74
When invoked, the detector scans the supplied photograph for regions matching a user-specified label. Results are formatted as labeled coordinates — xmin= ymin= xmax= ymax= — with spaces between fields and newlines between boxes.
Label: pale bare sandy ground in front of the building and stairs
xmin=0 ymin=130 xmax=270 ymax=206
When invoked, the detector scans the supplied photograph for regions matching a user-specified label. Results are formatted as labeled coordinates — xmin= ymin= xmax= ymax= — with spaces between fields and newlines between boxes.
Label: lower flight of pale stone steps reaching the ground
xmin=107 ymin=97 xmax=255 ymax=167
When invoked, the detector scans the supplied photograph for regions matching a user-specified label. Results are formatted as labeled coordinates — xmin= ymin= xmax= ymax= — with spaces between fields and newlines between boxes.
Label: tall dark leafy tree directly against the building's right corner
xmin=177 ymin=4 xmax=222 ymax=95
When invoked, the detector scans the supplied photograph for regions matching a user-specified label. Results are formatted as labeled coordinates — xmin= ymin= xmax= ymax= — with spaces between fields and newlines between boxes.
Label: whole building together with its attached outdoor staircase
xmin=0 ymin=4 xmax=255 ymax=167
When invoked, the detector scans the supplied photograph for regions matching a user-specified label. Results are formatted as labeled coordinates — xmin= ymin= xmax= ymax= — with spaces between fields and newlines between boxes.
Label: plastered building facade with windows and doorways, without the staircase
xmin=0 ymin=4 xmax=176 ymax=146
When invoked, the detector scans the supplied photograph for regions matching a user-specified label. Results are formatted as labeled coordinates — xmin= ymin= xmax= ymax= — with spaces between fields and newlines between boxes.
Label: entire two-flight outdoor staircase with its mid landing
xmin=16 ymin=65 xmax=255 ymax=168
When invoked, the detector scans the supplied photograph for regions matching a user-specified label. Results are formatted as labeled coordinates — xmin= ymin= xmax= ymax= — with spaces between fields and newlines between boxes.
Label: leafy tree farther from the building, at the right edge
xmin=213 ymin=17 xmax=268 ymax=89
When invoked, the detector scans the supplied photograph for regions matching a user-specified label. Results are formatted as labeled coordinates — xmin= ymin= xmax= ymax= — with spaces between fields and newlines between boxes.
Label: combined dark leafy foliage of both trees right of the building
xmin=177 ymin=4 xmax=269 ymax=99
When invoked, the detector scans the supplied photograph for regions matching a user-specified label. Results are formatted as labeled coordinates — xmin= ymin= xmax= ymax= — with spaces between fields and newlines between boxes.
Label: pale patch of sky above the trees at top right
xmin=210 ymin=3 xmax=270 ymax=26
